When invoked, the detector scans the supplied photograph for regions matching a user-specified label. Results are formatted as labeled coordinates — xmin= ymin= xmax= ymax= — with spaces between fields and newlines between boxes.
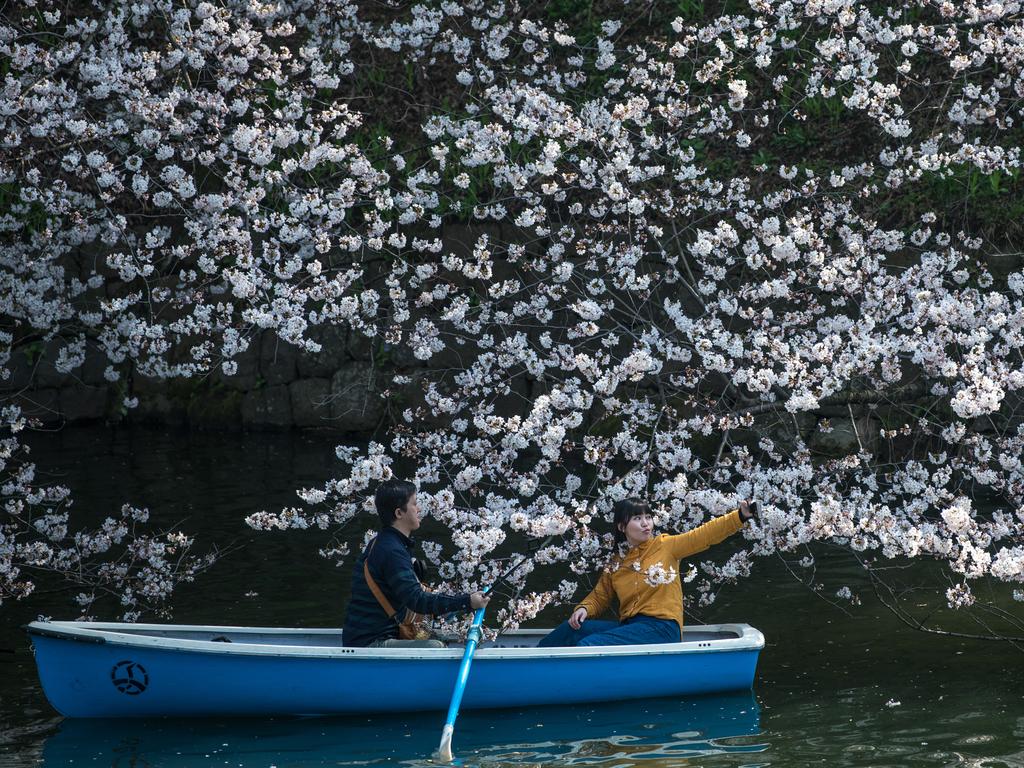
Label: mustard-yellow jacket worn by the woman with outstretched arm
xmin=577 ymin=510 xmax=743 ymax=636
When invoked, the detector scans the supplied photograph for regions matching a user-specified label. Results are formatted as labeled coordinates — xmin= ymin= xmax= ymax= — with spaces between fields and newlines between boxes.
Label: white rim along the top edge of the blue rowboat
xmin=25 ymin=622 xmax=765 ymax=662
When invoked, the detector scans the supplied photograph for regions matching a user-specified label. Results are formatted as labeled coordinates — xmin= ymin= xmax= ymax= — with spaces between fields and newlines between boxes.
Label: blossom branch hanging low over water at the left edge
xmin=0 ymin=407 xmax=217 ymax=622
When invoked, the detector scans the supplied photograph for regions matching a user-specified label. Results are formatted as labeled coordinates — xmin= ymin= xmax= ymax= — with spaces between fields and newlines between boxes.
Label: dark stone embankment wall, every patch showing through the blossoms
xmin=6 ymin=224 xmax=1019 ymax=456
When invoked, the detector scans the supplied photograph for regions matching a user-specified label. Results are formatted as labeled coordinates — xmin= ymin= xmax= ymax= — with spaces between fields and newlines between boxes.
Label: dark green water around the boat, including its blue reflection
xmin=0 ymin=429 xmax=1024 ymax=768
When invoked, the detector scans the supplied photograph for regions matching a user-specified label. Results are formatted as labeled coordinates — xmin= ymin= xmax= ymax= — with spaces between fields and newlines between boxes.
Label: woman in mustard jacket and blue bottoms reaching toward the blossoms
xmin=539 ymin=499 xmax=757 ymax=647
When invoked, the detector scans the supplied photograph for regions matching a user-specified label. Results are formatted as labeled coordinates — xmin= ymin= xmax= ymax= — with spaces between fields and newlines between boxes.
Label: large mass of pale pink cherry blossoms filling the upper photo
xmin=0 ymin=0 xmax=1024 ymax=639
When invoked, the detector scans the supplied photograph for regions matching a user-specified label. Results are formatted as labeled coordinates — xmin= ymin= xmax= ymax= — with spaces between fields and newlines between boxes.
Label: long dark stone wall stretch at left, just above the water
xmin=7 ymin=328 xmax=446 ymax=432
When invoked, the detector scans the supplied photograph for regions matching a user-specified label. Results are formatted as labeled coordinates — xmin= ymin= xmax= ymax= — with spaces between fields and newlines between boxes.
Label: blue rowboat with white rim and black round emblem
xmin=27 ymin=622 xmax=764 ymax=718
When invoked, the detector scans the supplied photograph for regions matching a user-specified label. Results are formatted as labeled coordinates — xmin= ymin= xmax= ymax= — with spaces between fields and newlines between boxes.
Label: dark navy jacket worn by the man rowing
xmin=342 ymin=527 xmax=470 ymax=647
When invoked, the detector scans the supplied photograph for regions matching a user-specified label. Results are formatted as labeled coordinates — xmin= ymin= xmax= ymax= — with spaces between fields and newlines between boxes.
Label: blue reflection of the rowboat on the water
xmin=42 ymin=696 xmax=767 ymax=768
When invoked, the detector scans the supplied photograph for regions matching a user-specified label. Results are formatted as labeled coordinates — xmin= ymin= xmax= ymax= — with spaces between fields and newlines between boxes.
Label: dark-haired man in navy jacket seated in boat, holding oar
xmin=342 ymin=479 xmax=490 ymax=648
